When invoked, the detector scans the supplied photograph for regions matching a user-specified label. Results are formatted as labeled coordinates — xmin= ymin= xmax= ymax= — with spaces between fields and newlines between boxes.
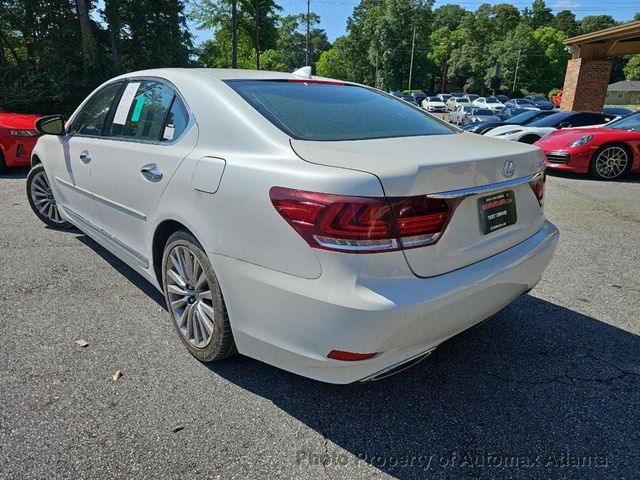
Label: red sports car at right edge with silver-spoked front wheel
xmin=535 ymin=112 xmax=640 ymax=180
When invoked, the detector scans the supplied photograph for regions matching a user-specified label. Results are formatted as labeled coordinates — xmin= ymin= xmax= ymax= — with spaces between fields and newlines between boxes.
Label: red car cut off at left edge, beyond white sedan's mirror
xmin=0 ymin=112 xmax=40 ymax=170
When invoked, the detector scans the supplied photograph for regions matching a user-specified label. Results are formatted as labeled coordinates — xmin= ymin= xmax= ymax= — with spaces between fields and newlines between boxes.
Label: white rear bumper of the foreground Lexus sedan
xmin=209 ymin=222 xmax=558 ymax=384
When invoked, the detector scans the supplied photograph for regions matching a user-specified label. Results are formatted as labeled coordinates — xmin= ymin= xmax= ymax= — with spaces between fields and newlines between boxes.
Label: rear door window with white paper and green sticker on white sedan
xmin=110 ymin=80 xmax=177 ymax=141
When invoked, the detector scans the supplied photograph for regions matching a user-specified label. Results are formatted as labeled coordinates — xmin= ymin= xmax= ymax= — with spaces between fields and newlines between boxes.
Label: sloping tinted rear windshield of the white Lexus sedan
xmin=227 ymin=80 xmax=455 ymax=141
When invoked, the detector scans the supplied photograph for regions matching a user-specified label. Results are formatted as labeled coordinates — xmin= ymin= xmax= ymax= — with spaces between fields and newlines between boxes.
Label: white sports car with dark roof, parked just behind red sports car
xmin=485 ymin=112 xmax=617 ymax=144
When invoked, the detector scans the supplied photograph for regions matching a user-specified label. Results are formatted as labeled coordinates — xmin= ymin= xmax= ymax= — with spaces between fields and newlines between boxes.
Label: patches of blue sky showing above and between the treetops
xmin=193 ymin=0 xmax=640 ymax=43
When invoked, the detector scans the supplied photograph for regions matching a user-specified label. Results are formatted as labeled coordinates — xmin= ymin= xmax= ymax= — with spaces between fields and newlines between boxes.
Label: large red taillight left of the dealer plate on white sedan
xmin=269 ymin=187 xmax=451 ymax=253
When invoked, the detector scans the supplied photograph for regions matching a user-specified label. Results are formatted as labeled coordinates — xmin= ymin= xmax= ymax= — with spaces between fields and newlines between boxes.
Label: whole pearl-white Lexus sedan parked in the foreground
xmin=27 ymin=69 xmax=558 ymax=384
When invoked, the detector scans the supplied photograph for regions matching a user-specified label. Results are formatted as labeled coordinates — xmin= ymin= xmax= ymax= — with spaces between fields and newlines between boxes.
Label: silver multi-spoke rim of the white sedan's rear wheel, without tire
xmin=165 ymin=245 xmax=216 ymax=348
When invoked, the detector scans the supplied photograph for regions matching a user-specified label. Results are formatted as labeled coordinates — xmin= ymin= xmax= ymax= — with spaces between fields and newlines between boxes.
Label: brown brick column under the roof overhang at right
xmin=560 ymin=58 xmax=613 ymax=112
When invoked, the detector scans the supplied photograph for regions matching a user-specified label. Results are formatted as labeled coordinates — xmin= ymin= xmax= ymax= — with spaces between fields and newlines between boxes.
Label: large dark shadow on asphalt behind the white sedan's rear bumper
xmin=209 ymin=295 xmax=640 ymax=479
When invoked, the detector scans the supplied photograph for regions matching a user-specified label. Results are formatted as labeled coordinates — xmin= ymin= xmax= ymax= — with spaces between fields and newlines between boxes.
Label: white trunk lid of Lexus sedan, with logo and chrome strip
xmin=291 ymin=134 xmax=544 ymax=277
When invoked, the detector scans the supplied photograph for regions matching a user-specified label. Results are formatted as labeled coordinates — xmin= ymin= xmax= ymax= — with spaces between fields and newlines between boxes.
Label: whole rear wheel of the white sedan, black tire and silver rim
xmin=162 ymin=230 xmax=236 ymax=362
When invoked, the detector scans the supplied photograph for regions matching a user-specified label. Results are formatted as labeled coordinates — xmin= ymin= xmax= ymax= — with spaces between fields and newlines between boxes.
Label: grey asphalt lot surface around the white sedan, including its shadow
xmin=0 ymin=167 xmax=640 ymax=480
